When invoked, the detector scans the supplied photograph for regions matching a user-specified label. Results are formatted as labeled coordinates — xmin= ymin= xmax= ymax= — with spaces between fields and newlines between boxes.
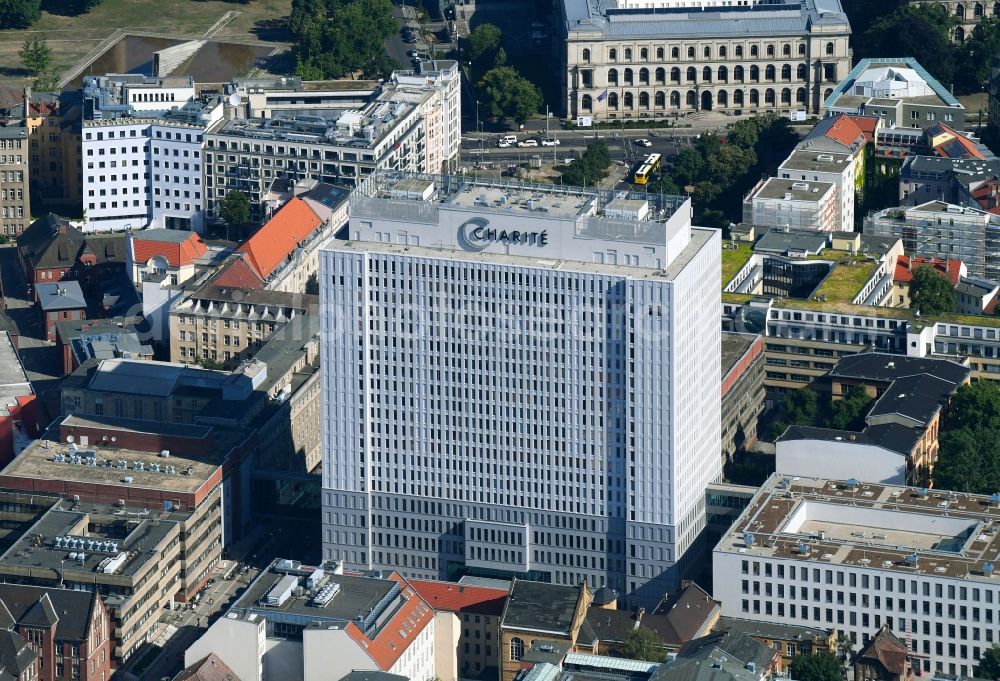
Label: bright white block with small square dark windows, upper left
xmin=81 ymin=74 xmax=223 ymax=232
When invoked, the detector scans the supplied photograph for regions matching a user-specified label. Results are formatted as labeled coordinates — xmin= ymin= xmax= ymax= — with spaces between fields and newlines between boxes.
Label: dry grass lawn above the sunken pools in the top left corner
xmin=0 ymin=0 xmax=292 ymax=82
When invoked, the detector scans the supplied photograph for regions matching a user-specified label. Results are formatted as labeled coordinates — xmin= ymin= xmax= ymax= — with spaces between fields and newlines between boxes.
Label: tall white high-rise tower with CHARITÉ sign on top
xmin=320 ymin=171 xmax=721 ymax=602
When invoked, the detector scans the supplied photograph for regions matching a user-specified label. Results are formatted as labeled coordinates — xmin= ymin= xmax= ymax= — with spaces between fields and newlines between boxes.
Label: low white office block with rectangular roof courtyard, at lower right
xmin=712 ymin=474 xmax=1000 ymax=676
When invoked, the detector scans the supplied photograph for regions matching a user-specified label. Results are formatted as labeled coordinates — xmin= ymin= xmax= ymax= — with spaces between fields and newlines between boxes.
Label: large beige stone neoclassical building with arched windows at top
xmin=558 ymin=0 xmax=851 ymax=121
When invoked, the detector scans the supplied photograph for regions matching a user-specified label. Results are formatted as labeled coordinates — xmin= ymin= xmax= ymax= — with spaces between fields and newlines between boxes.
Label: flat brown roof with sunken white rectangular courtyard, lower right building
xmin=715 ymin=473 xmax=1000 ymax=581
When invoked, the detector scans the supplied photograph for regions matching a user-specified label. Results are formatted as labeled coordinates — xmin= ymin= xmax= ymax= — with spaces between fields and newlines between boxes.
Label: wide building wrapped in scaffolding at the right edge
xmin=865 ymin=200 xmax=1000 ymax=281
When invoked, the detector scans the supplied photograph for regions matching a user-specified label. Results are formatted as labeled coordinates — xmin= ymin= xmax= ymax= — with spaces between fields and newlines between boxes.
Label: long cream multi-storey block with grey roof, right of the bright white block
xmin=205 ymin=61 xmax=461 ymax=218
